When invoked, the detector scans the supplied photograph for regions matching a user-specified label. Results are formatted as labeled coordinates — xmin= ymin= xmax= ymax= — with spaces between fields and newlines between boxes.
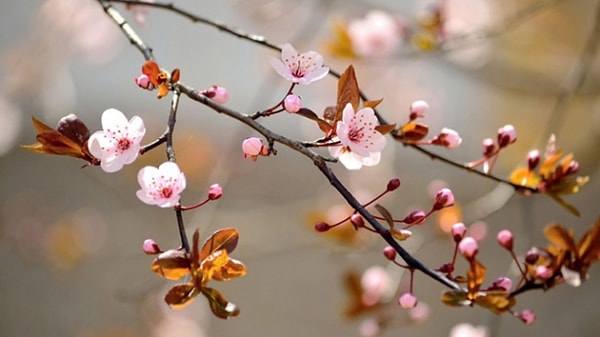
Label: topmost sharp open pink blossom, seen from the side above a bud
xmin=270 ymin=43 xmax=329 ymax=84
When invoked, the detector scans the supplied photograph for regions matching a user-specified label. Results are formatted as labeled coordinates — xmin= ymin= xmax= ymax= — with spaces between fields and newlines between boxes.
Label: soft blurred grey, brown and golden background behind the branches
xmin=0 ymin=0 xmax=600 ymax=337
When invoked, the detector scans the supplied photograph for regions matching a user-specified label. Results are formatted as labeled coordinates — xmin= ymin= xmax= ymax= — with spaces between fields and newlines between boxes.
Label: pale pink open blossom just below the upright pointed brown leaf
xmin=329 ymin=103 xmax=386 ymax=170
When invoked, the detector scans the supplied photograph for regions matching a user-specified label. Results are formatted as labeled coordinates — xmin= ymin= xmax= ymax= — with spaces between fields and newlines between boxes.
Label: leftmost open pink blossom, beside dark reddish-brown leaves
xmin=88 ymin=109 xmax=146 ymax=172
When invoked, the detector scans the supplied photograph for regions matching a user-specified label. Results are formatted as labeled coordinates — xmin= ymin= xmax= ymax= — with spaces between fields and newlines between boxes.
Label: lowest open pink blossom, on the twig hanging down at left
xmin=136 ymin=162 xmax=186 ymax=208
